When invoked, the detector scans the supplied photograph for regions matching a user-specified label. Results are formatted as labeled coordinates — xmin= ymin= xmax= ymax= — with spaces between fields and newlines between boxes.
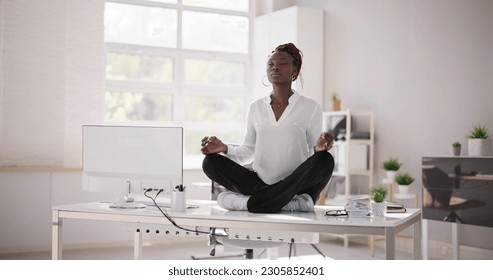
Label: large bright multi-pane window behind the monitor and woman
xmin=102 ymin=0 xmax=253 ymax=168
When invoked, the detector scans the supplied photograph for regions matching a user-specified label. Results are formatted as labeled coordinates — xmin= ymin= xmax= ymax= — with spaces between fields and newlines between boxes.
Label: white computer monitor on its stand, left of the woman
xmin=82 ymin=125 xmax=183 ymax=208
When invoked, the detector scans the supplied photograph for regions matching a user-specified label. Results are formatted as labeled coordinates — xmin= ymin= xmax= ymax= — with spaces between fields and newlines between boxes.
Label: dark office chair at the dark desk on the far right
xmin=423 ymin=166 xmax=486 ymax=224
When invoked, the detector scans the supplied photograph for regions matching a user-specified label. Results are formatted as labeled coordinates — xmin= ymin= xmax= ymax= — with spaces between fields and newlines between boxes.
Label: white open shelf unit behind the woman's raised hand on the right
xmin=322 ymin=109 xmax=375 ymax=205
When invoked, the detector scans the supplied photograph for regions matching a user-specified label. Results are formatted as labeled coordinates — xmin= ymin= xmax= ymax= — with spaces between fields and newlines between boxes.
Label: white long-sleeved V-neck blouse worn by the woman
xmin=226 ymin=91 xmax=322 ymax=184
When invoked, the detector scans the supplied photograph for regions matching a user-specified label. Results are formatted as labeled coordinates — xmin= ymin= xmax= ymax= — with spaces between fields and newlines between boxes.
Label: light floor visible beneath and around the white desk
xmin=0 ymin=236 xmax=411 ymax=260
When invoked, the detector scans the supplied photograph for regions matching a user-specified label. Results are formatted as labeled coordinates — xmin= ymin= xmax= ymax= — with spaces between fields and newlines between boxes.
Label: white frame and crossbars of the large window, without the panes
xmin=103 ymin=0 xmax=255 ymax=169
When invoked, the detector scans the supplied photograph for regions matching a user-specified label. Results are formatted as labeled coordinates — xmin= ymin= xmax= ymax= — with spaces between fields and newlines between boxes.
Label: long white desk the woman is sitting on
xmin=52 ymin=200 xmax=421 ymax=259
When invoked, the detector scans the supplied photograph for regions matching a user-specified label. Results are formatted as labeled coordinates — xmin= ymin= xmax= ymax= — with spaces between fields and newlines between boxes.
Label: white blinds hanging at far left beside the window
xmin=0 ymin=0 xmax=104 ymax=167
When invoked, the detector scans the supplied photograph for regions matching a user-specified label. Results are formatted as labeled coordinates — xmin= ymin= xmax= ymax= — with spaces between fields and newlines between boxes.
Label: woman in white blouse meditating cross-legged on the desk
xmin=201 ymin=43 xmax=334 ymax=213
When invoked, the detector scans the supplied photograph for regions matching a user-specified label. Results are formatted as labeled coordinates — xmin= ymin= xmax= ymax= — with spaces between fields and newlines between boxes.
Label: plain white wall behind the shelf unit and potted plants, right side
xmin=288 ymin=0 xmax=493 ymax=249
